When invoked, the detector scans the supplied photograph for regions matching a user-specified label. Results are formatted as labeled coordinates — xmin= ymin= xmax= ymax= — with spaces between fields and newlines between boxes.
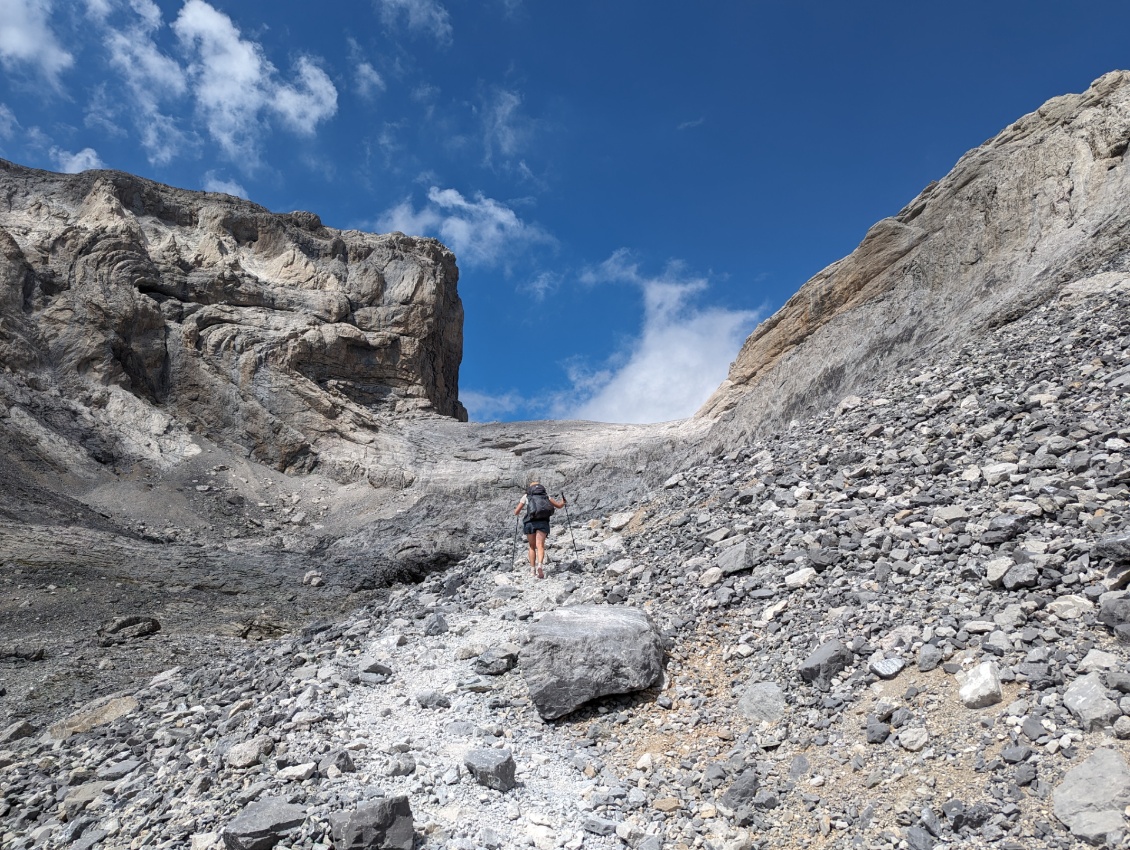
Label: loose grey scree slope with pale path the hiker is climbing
xmin=0 ymin=272 xmax=1130 ymax=850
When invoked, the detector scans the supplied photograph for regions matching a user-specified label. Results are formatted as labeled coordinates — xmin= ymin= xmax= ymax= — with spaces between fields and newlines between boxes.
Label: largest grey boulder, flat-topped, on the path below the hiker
xmin=519 ymin=605 xmax=663 ymax=720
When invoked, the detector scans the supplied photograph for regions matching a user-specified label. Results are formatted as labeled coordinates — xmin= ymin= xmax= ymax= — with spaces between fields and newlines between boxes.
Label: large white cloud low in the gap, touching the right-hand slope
xmin=555 ymin=251 xmax=758 ymax=423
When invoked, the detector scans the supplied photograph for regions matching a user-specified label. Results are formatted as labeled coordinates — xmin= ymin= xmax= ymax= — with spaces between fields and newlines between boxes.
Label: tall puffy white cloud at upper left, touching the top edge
xmin=173 ymin=0 xmax=338 ymax=168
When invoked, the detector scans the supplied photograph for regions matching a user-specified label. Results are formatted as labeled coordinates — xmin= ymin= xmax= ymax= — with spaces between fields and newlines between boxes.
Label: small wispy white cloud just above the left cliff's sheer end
xmin=377 ymin=187 xmax=554 ymax=266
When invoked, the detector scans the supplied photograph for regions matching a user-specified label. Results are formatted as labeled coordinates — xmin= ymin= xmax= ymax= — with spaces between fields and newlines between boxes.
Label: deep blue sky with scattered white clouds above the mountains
xmin=0 ymin=0 xmax=1130 ymax=422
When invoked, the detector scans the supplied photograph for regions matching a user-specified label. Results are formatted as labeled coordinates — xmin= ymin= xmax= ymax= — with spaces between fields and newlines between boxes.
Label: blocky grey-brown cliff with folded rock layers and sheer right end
xmin=0 ymin=162 xmax=467 ymax=479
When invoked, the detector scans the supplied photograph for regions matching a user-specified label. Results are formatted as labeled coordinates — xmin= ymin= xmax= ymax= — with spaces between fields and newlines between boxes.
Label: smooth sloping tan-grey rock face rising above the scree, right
xmin=697 ymin=71 xmax=1130 ymax=441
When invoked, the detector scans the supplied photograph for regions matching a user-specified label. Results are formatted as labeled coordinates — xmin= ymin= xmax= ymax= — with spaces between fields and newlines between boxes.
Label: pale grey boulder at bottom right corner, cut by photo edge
xmin=1052 ymin=749 xmax=1130 ymax=844
